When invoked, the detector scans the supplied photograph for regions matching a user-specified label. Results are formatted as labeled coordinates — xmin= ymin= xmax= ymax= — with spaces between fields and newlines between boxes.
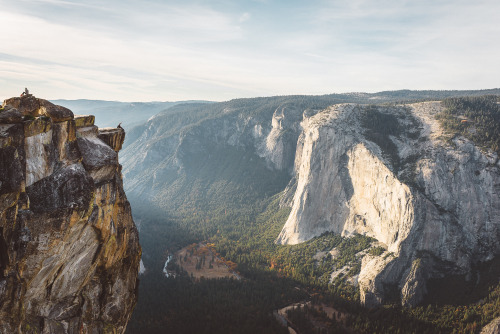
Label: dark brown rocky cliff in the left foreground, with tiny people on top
xmin=0 ymin=95 xmax=141 ymax=333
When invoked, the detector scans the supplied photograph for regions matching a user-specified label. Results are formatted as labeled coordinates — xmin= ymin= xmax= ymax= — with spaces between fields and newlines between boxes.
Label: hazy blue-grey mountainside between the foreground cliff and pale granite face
xmin=122 ymin=98 xmax=308 ymax=210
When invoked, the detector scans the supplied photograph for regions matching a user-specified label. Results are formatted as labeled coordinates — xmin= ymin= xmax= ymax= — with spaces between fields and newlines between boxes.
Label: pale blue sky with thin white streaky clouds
xmin=0 ymin=0 xmax=500 ymax=101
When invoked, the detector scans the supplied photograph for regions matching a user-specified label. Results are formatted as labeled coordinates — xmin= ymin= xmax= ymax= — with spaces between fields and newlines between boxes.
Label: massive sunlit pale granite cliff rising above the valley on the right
xmin=277 ymin=102 xmax=500 ymax=306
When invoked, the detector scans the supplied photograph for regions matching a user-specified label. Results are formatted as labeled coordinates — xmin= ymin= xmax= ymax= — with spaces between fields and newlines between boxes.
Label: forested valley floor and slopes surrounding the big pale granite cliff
xmin=120 ymin=90 xmax=500 ymax=333
